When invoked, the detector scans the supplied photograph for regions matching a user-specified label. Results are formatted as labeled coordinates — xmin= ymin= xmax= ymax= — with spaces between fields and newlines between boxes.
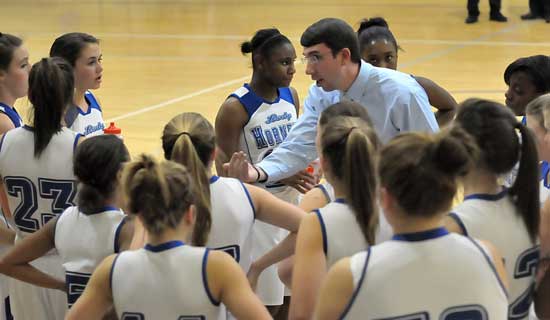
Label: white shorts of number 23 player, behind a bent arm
xmin=9 ymin=254 xmax=67 ymax=320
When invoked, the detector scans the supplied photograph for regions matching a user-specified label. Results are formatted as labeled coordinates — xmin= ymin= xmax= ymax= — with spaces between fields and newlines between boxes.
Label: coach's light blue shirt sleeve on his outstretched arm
xmin=257 ymin=84 xmax=337 ymax=182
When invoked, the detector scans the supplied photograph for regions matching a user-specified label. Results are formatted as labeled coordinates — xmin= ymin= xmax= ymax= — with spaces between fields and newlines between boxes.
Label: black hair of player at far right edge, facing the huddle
xmin=504 ymin=55 xmax=550 ymax=94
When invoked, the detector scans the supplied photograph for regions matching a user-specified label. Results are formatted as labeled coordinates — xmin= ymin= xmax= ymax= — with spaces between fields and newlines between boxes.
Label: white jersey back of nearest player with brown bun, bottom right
xmin=341 ymin=228 xmax=508 ymax=320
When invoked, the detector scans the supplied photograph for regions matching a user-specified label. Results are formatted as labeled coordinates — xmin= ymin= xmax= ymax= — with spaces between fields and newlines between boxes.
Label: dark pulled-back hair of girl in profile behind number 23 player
xmin=50 ymin=32 xmax=99 ymax=67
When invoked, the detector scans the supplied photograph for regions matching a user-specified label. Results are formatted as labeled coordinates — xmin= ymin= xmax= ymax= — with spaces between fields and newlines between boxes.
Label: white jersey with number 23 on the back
xmin=0 ymin=126 xmax=80 ymax=238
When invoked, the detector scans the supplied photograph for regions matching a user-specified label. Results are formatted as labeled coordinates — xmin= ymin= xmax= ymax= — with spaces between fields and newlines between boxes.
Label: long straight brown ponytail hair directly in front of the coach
xmin=320 ymin=116 xmax=379 ymax=245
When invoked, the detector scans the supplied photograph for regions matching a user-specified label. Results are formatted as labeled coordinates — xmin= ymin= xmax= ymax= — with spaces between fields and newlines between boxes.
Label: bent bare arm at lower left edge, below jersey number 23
xmin=0 ymin=219 xmax=65 ymax=291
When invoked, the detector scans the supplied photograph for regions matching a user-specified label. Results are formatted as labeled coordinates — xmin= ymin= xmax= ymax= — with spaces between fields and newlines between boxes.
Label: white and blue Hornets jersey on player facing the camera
xmin=230 ymin=84 xmax=298 ymax=196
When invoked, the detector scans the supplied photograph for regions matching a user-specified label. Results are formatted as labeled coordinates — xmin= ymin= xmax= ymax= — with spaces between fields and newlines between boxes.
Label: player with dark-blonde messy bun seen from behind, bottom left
xmin=67 ymin=155 xmax=270 ymax=320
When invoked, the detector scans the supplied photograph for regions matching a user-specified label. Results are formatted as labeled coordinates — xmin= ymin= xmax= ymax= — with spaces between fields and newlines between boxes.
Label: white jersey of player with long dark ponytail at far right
xmin=450 ymin=190 xmax=539 ymax=319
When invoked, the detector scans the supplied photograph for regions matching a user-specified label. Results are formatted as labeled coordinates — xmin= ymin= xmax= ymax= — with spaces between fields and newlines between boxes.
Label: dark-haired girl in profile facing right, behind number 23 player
xmin=50 ymin=32 xmax=105 ymax=136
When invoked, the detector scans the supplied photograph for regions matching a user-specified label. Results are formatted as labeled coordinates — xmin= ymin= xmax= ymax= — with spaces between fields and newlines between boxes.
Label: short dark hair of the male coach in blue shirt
xmin=300 ymin=18 xmax=361 ymax=63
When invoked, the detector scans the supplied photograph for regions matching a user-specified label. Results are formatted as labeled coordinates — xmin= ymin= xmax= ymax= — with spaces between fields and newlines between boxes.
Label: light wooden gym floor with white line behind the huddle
xmin=0 ymin=0 xmax=550 ymax=156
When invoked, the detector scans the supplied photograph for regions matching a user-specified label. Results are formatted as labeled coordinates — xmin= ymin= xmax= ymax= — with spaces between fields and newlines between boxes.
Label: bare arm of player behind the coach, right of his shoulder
xmin=415 ymin=77 xmax=458 ymax=127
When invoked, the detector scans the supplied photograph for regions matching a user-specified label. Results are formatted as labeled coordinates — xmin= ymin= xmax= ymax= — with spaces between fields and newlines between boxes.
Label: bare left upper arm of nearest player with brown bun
xmin=314 ymin=258 xmax=353 ymax=320
